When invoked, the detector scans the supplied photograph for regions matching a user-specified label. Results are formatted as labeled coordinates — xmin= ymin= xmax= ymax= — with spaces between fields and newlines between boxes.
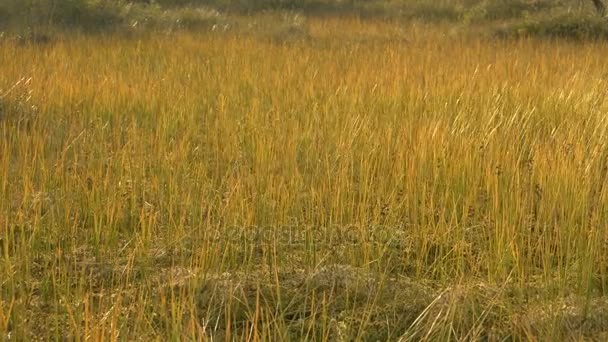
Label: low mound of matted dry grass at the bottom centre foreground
xmin=198 ymin=265 xmax=432 ymax=341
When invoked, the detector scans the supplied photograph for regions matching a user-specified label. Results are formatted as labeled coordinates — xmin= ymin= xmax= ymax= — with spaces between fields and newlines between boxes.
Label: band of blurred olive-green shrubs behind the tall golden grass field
xmin=0 ymin=0 xmax=608 ymax=39
